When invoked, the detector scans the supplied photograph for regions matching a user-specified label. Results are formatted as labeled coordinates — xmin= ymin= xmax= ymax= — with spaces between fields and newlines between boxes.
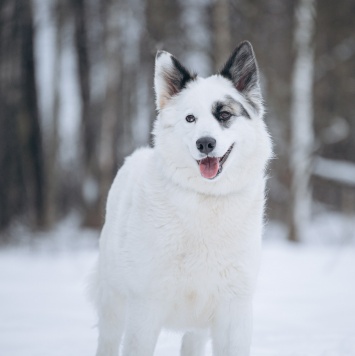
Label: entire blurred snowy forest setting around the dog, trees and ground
xmin=0 ymin=0 xmax=355 ymax=356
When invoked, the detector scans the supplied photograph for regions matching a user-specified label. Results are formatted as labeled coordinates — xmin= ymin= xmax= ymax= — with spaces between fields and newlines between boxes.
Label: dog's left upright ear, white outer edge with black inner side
xmin=154 ymin=51 xmax=196 ymax=110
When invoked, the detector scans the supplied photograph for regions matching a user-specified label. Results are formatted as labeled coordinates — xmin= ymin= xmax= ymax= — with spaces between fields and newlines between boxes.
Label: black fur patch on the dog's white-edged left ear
xmin=164 ymin=56 xmax=196 ymax=97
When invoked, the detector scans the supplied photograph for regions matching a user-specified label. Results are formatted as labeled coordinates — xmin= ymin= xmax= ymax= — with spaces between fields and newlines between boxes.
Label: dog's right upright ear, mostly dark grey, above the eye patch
xmin=219 ymin=41 xmax=262 ymax=111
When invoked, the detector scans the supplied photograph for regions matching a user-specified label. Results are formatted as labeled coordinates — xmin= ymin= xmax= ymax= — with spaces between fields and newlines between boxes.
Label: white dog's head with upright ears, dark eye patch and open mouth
xmin=154 ymin=42 xmax=272 ymax=194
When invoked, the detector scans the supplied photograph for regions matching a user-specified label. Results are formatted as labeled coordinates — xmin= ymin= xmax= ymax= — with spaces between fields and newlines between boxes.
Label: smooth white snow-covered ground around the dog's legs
xmin=0 ymin=224 xmax=355 ymax=356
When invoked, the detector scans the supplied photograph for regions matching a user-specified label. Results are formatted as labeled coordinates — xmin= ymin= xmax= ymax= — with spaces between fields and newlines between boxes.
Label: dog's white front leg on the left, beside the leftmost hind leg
xmin=122 ymin=299 xmax=163 ymax=356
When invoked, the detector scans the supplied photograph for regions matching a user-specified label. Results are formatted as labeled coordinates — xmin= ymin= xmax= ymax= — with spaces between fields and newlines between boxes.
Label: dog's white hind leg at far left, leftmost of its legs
xmin=96 ymin=296 xmax=125 ymax=356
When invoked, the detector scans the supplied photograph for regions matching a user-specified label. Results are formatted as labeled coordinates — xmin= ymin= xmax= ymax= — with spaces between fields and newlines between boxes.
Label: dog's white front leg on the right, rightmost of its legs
xmin=212 ymin=298 xmax=252 ymax=356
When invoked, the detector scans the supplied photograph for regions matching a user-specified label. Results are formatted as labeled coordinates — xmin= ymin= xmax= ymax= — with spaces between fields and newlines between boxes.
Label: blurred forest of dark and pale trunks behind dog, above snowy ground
xmin=0 ymin=0 xmax=355 ymax=243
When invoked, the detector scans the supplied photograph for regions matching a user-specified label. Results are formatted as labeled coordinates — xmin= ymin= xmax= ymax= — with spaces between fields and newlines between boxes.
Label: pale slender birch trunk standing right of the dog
xmin=289 ymin=0 xmax=315 ymax=241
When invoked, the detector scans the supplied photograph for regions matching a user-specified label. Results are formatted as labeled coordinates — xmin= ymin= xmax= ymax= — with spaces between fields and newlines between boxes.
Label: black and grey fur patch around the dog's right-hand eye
xmin=212 ymin=95 xmax=250 ymax=128
